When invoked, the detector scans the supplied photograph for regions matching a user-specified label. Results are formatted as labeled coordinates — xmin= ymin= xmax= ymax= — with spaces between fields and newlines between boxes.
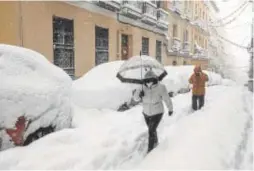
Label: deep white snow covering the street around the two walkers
xmin=0 ymin=85 xmax=253 ymax=170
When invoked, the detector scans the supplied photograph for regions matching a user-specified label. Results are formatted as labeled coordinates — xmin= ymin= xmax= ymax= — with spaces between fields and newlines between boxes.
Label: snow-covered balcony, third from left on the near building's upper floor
xmin=141 ymin=1 xmax=157 ymax=25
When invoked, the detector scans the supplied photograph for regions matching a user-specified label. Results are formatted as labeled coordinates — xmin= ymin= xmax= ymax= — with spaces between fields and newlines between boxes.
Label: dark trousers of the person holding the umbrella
xmin=144 ymin=113 xmax=162 ymax=153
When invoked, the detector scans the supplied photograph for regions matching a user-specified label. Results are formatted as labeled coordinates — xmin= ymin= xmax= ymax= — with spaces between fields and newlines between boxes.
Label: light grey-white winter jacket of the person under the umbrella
xmin=134 ymin=83 xmax=173 ymax=116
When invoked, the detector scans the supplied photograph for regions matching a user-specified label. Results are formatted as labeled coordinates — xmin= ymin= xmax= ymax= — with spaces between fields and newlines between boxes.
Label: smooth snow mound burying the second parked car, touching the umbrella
xmin=72 ymin=61 xmax=137 ymax=110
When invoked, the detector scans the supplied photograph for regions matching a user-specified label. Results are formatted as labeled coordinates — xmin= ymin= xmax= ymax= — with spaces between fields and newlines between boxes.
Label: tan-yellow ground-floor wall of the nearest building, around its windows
xmin=0 ymin=1 xmax=166 ymax=77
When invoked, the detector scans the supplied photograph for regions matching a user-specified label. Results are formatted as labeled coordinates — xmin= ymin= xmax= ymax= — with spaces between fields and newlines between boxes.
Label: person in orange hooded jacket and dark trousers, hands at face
xmin=189 ymin=66 xmax=208 ymax=110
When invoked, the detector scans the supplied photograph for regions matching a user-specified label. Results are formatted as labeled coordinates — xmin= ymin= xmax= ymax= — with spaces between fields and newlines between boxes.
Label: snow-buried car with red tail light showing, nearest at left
xmin=0 ymin=44 xmax=72 ymax=150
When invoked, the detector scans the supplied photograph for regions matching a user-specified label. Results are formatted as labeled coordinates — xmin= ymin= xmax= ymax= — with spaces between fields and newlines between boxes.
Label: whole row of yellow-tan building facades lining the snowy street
xmin=0 ymin=1 xmax=208 ymax=78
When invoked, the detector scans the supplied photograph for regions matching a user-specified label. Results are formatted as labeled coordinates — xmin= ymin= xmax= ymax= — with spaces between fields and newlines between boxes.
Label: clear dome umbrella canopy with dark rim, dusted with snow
xmin=117 ymin=55 xmax=167 ymax=84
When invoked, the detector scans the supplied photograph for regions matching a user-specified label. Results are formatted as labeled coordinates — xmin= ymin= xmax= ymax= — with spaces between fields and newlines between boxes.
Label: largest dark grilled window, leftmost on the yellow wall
xmin=53 ymin=17 xmax=75 ymax=77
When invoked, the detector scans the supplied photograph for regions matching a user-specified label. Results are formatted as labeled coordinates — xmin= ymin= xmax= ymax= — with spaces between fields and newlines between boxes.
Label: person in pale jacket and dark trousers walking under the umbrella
xmin=136 ymin=70 xmax=173 ymax=153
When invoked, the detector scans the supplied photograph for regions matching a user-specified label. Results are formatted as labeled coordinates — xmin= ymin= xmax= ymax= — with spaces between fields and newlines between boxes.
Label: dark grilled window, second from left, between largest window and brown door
xmin=95 ymin=26 xmax=108 ymax=65
